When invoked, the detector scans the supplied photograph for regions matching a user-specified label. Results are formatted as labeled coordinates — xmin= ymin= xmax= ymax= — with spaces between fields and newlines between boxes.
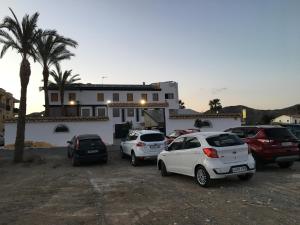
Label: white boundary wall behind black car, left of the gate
xmin=5 ymin=120 xmax=113 ymax=146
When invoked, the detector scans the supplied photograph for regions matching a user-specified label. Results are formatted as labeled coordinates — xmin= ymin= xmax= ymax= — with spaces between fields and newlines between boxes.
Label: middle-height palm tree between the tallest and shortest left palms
xmin=36 ymin=35 xmax=77 ymax=116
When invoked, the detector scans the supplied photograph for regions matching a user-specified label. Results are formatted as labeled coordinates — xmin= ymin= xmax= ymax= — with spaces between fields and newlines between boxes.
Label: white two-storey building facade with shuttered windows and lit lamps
xmin=49 ymin=81 xmax=179 ymax=134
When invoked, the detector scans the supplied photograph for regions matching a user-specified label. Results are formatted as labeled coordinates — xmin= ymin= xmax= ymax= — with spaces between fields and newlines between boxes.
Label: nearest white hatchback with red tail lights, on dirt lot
xmin=157 ymin=132 xmax=255 ymax=187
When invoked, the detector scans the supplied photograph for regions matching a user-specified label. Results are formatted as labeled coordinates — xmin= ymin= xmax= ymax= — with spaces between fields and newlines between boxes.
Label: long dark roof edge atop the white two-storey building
xmin=48 ymin=83 xmax=161 ymax=91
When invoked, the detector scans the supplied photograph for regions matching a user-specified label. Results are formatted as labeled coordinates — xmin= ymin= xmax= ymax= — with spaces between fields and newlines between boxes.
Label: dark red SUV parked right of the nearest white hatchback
xmin=226 ymin=125 xmax=300 ymax=168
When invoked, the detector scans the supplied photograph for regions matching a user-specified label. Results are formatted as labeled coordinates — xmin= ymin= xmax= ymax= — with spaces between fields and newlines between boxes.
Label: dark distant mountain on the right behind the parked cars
xmin=209 ymin=104 xmax=300 ymax=124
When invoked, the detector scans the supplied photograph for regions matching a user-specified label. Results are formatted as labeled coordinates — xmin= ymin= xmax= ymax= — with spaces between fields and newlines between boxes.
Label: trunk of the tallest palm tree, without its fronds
xmin=14 ymin=56 xmax=31 ymax=163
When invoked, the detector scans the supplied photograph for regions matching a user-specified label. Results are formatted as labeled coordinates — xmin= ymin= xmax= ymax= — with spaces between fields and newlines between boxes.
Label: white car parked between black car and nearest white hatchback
xmin=120 ymin=130 xmax=167 ymax=166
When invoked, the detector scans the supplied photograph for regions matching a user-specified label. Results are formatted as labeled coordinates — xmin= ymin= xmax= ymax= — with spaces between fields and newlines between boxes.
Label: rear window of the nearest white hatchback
xmin=206 ymin=134 xmax=244 ymax=147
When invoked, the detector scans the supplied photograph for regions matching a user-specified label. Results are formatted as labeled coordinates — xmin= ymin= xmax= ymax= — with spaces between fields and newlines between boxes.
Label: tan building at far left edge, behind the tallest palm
xmin=0 ymin=88 xmax=19 ymax=133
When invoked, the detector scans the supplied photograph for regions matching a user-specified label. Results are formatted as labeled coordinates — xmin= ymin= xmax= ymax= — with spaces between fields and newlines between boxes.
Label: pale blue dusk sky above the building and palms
xmin=0 ymin=0 xmax=300 ymax=113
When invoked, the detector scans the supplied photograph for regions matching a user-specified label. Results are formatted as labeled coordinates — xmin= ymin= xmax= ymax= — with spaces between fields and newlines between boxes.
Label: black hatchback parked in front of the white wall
xmin=67 ymin=134 xmax=107 ymax=166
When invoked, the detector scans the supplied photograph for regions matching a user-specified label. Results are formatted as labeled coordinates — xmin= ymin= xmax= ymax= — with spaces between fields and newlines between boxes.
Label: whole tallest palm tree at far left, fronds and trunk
xmin=0 ymin=8 xmax=53 ymax=162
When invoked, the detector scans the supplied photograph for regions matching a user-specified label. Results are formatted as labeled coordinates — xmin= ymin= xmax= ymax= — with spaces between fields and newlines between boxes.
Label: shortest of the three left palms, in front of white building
xmin=49 ymin=63 xmax=80 ymax=116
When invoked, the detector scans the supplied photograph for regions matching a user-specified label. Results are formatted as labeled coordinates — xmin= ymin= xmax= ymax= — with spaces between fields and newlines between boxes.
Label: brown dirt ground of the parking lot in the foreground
xmin=0 ymin=147 xmax=300 ymax=225
